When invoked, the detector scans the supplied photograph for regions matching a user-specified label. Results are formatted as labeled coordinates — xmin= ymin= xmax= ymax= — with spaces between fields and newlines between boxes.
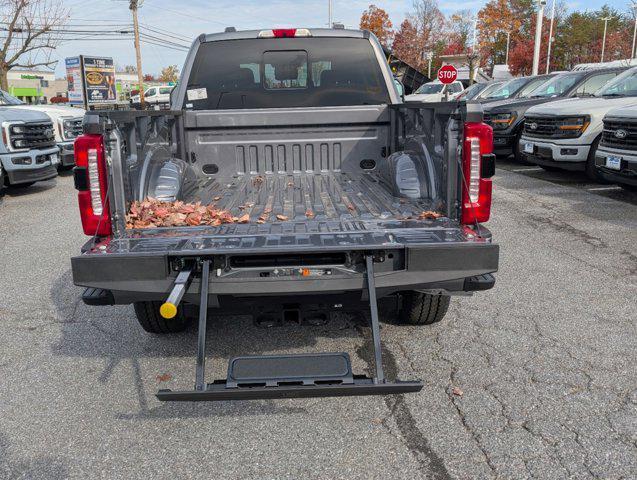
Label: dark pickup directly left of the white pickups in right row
xmin=484 ymin=68 xmax=626 ymax=159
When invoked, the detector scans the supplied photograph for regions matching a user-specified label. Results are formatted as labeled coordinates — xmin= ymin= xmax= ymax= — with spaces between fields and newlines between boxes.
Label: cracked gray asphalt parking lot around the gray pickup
xmin=0 ymin=163 xmax=637 ymax=480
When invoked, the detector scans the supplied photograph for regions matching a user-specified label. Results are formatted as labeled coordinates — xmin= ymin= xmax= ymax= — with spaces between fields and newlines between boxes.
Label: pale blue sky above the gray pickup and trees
xmin=38 ymin=0 xmax=629 ymax=77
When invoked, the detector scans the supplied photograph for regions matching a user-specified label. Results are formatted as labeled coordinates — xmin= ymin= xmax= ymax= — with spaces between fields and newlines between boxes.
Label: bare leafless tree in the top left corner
xmin=0 ymin=0 xmax=68 ymax=90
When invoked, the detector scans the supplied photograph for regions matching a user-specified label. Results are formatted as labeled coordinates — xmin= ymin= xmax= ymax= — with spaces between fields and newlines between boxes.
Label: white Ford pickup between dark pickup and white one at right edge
xmin=519 ymin=68 xmax=637 ymax=181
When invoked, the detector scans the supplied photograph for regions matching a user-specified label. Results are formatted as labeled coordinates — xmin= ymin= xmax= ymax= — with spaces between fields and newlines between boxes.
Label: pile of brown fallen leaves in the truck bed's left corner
xmin=126 ymin=197 xmax=250 ymax=229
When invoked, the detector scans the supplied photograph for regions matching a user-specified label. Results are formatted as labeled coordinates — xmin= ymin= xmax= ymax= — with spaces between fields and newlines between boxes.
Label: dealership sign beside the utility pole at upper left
xmin=66 ymin=55 xmax=117 ymax=108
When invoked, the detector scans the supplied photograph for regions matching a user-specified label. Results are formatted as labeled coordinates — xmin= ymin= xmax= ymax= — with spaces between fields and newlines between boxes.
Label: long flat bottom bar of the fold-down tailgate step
xmin=157 ymin=377 xmax=423 ymax=402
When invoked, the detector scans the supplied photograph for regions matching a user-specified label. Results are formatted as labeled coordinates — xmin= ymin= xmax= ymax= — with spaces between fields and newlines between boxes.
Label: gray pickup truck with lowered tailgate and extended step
xmin=72 ymin=29 xmax=499 ymax=401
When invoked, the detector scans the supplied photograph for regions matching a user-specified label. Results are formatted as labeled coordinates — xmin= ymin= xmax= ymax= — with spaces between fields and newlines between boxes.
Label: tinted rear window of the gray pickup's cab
xmin=185 ymin=38 xmax=390 ymax=110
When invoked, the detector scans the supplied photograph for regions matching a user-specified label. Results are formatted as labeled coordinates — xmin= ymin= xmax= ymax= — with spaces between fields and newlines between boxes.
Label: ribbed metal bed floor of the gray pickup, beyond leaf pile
xmin=176 ymin=172 xmax=433 ymax=231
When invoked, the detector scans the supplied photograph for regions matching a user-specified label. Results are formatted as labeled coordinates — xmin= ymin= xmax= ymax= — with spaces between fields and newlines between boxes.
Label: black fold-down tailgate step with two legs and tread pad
xmin=156 ymin=255 xmax=423 ymax=402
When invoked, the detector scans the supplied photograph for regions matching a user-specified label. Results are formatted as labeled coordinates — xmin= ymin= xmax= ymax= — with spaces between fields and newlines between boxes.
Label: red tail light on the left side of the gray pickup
xmin=74 ymin=135 xmax=113 ymax=237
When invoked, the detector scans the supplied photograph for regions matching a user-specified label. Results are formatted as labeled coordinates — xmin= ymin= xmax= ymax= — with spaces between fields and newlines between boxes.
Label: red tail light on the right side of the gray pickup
xmin=461 ymin=123 xmax=495 ymax=225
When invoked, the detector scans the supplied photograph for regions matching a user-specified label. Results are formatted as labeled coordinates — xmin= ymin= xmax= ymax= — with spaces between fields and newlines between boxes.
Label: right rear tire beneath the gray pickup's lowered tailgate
xmin=379 ymin=292 xmax=451 ymax=325
